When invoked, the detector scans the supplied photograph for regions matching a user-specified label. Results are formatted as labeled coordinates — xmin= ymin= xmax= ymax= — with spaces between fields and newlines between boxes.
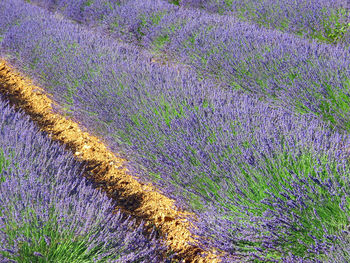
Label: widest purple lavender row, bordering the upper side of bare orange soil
xmin=0 ymin=0 xmax=349 ymax=260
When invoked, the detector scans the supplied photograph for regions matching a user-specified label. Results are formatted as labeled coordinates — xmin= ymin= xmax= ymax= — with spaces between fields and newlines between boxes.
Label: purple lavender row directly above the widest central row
xmin=28 ymin=0 xmax=350 ymax=133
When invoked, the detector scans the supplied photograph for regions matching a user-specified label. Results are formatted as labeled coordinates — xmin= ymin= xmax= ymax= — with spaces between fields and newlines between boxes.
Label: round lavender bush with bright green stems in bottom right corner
xmin=191 ymin=145 xmax=349 ymax=262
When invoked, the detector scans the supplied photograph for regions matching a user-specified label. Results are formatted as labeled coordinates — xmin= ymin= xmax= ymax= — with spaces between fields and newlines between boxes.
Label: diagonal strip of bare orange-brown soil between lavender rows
xmin=0 ymin=58 xmax=230 ymax=263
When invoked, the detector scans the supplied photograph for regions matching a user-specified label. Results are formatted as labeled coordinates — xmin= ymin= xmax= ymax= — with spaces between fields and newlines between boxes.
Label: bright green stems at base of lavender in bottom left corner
xmin=0 ymin=206 xmax=119 ymax=263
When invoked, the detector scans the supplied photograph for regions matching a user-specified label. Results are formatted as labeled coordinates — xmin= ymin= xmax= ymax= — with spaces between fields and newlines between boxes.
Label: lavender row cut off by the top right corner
xmin=168 ymin=0 xmax=350 ymax=44
